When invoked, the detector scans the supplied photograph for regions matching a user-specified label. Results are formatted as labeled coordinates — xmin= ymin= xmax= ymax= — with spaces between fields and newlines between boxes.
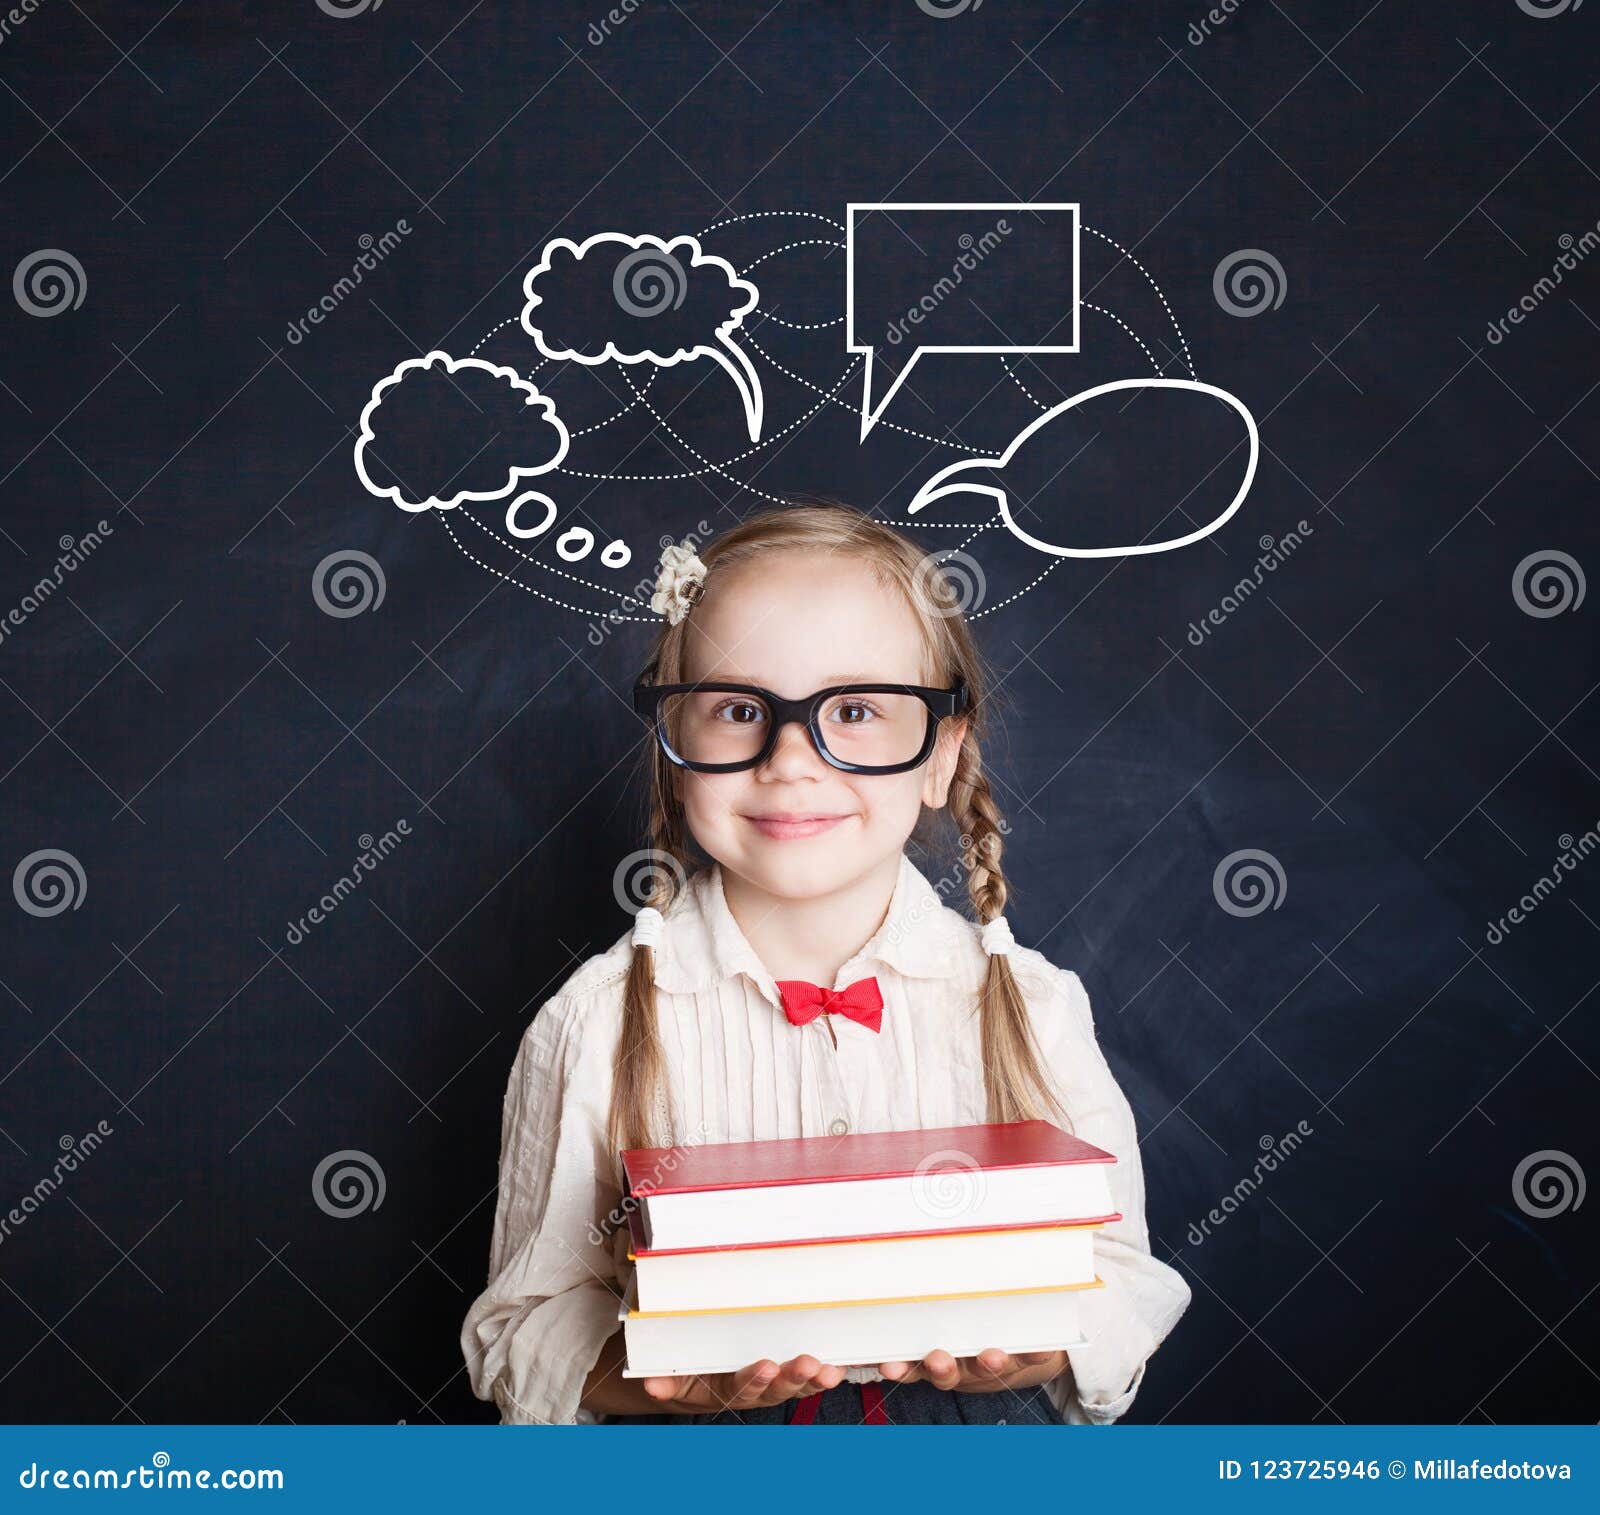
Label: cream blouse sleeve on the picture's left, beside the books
xmin=461 ymin=998 xmax=627 ymax=1425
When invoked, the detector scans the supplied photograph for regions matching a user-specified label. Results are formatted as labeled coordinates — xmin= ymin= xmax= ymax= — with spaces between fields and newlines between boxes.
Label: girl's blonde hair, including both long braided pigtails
xmin=606 ymin=504 xmax=1070 ymax=1152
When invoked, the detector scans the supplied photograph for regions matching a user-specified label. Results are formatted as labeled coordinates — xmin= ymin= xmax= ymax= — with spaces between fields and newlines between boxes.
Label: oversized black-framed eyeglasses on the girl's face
xmin=634 ymin=670 xmax=968 ymax=773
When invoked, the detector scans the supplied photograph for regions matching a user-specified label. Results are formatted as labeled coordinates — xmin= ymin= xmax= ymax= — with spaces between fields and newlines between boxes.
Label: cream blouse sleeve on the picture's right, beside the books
xmin=1040 ymin=969 xmax=1190 ymax=1425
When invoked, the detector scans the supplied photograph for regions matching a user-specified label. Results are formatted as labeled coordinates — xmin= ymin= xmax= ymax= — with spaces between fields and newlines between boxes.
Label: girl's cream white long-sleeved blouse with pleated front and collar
xmin=461 ymin=859 xmax=1190 ymax=1425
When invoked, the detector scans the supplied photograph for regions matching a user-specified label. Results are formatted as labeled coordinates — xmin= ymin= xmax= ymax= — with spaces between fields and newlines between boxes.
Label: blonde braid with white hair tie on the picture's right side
xmin=949 ymin=733 xmax=1072 ymax=1129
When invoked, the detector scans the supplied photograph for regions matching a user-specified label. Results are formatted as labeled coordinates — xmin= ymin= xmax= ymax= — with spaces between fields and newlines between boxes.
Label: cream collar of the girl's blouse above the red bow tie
xmin=654 ymin=854 xmax=965 ymax=1005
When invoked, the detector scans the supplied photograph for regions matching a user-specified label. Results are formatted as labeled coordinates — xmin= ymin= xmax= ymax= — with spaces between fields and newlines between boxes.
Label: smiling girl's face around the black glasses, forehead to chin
xmin=677 ymin=549 xmax=963 ymax=899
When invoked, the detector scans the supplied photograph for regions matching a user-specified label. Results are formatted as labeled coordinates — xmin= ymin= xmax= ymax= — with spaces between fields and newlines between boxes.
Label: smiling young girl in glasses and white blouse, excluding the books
xmin=461 ymin=506 xmax=1189 ymax=1424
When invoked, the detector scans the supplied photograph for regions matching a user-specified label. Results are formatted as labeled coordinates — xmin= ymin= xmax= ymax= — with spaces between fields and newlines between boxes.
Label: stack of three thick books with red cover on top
xmin=618 ymin=1120 xmax=1122 ymax=1377
